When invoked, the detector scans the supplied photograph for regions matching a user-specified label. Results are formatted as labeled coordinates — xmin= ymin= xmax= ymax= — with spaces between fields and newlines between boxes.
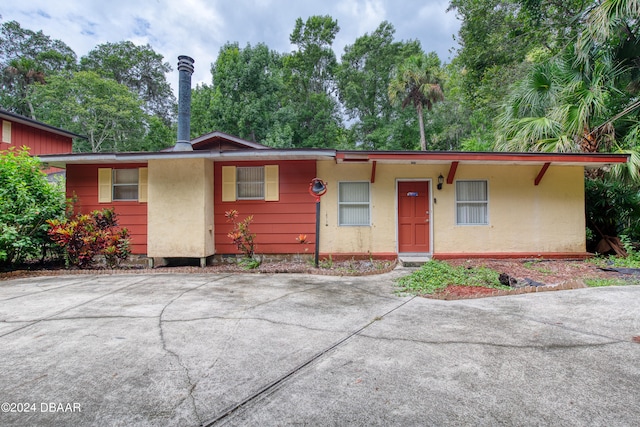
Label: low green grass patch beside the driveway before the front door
xmin=397 ymin=260 xmax=510 ymax=295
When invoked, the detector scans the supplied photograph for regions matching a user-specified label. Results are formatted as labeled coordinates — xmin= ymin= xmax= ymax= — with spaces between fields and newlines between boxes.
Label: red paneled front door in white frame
xmin=398 ymin=181 xmax=430 ymax=252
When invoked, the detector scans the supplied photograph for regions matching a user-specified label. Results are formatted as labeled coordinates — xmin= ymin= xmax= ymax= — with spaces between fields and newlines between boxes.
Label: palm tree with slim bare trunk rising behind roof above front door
xmin=389 ymin=52 xmax=444 ymax=151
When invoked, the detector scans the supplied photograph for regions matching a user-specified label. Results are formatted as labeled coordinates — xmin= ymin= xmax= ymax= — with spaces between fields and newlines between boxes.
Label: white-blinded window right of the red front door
xmin=456 ymin=181 xmax=489 ymax=225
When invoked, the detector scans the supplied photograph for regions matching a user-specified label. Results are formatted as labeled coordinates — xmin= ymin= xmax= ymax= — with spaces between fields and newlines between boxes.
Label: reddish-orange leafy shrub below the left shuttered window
xmin=48 ymin=209 xmax=131 ymax=268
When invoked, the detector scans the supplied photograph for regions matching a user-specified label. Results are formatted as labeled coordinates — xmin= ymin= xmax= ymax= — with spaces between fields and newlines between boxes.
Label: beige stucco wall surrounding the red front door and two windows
xmin=317 ymin=161 xmax=586 ymax=255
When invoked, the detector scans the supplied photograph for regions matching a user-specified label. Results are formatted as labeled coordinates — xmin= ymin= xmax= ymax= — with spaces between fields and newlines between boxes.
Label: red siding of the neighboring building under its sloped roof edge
xmin=0 ymin=119 xmax=73 ymax=156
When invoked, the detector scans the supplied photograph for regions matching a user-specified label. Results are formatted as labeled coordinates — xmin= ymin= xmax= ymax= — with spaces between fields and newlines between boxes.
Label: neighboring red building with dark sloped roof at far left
xmin=0 ymin=109 xmax=82 ymax=156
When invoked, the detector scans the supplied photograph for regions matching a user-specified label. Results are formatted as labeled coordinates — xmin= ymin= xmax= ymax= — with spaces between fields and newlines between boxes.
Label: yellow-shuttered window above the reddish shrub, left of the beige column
xmin=98 ymin=167 xmax=148 ymax=203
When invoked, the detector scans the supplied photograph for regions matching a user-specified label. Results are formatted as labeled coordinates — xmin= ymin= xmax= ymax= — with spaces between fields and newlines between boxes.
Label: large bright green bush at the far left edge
xmin=0 ymin=147 xmax=65 ymax=268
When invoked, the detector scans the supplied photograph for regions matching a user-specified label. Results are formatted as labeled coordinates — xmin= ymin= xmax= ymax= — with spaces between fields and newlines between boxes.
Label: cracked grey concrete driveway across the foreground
xmin=0 ymin=270 xmax=640 ymax=426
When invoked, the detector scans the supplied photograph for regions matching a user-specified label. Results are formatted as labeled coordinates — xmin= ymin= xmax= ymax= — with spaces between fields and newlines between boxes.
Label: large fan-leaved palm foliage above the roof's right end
xmin=496 ymin=0 xmax=640 ymax=181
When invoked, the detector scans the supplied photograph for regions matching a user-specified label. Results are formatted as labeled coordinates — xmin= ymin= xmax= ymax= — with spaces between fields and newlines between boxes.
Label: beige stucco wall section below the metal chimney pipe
xmin=147 ymin=159 xmax=214 ymax=258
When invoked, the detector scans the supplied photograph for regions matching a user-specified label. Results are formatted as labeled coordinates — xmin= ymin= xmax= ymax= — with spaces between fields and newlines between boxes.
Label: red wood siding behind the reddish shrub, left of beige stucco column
xmin=67 ymin=164 xmax=147 ymax=255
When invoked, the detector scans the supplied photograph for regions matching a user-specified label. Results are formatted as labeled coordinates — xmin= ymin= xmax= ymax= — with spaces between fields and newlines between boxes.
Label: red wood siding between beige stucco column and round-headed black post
xmin=214 ymin=160 xmax=316 ymax=254
